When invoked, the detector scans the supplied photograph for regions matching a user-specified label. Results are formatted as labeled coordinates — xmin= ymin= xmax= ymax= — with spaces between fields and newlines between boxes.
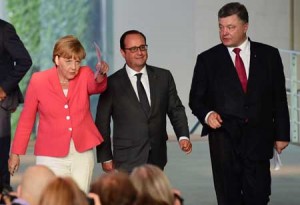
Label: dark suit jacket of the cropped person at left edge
xmin=0 ymin=19 xmax=32 ymax=109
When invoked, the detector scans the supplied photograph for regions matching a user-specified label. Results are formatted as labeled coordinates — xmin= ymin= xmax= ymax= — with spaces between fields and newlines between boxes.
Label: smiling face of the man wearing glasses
xmin=121 ymin=34 xmax=148 ymax=72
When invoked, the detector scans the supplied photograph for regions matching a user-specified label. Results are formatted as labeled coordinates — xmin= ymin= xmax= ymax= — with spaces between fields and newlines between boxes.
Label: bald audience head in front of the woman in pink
xmin=17 ymin=165 xmax=55 ymax=205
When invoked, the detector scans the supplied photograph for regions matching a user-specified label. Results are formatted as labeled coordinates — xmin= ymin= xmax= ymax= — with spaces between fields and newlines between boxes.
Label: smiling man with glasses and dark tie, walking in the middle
xmin=96 ymin=30 xmax=192 ymax=172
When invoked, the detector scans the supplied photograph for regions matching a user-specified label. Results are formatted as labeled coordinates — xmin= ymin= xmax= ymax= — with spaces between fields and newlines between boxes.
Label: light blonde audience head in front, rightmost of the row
xmin=130 ymin=164 xmax=174 ymax=205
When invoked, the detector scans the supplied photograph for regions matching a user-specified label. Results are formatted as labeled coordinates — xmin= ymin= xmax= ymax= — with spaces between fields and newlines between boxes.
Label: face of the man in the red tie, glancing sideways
xmin=219 ymin=14 xmax=248 ymax=47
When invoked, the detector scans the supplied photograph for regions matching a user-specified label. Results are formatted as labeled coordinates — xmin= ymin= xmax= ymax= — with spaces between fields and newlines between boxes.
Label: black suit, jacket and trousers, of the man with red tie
xmin=189 ymin=41 xmax=290 ymax=204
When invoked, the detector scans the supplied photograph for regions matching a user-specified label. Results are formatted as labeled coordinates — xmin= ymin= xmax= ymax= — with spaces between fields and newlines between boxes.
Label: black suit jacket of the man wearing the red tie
xmin=189 ymin=41 xmax=290 ymax=159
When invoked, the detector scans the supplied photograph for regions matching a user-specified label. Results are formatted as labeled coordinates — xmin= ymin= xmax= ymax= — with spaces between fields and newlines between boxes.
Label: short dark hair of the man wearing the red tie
xmin=218 ymin=2 xmax=249 ymax=23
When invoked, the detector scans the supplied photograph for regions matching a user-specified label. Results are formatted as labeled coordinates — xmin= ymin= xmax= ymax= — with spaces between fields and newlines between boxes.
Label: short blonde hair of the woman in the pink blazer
xmin=52 ymin=35 xmax=86 ymax=63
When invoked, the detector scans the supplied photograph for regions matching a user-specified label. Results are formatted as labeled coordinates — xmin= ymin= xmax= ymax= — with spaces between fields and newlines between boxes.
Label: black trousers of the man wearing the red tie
xmin=209 ymin=130 xmax=271 ymax=205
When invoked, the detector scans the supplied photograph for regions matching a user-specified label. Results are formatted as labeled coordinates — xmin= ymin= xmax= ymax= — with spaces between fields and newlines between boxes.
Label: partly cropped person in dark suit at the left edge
xmin=0 ymin=19 xmax=32 ymax=189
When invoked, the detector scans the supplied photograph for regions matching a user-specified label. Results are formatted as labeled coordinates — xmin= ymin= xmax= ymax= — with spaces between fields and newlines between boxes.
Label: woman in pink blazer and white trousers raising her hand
xmin=9 ymin=35 xmax=108 ymax=192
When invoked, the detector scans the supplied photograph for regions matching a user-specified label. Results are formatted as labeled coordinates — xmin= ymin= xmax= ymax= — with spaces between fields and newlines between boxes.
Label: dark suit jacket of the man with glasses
xmin=96 ymin=65 xmax=189 ymax=172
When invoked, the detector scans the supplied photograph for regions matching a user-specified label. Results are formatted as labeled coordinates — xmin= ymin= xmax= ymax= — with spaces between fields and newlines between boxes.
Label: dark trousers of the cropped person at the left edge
xmin=0 ymin=107 xmax=11 ymax=186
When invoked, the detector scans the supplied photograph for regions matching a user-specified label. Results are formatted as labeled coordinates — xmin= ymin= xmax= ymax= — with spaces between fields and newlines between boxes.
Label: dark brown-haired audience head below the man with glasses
xmin=90 ymin=172 xmax=137 ymax=205
